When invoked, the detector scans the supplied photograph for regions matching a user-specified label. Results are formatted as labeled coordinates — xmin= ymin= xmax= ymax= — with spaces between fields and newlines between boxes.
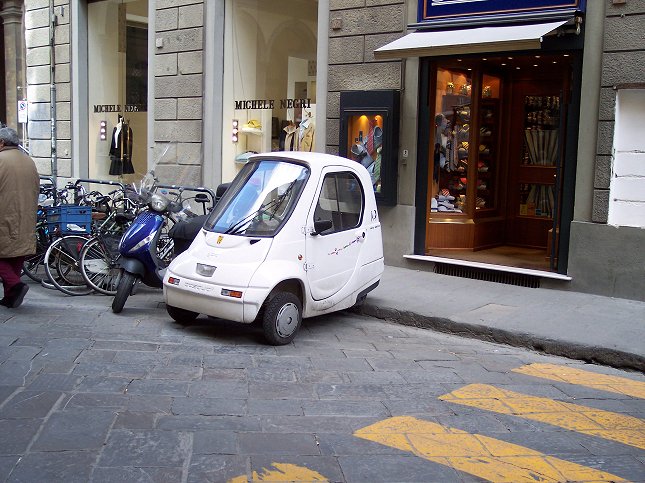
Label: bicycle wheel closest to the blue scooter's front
xmin=80 ymin=237 xmax=121 ymax=296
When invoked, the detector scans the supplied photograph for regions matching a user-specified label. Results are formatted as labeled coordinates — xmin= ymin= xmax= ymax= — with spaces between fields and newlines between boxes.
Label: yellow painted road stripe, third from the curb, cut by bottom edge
xmin=354 ymin=416 xmax=624 ymax=483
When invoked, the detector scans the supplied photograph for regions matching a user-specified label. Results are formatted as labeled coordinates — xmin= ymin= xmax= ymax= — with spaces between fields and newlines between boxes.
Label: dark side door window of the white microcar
xmin=314 ymin=172 xmax=365 ymax=235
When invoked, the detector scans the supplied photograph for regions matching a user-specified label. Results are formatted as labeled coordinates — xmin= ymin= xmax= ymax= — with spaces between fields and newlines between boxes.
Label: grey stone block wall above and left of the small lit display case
xmin=326 ymin=0 xmax=406 ymax=154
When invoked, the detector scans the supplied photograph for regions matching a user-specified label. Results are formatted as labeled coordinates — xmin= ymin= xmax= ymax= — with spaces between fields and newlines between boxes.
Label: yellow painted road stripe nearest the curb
xmin=513 ymin=364 xmax=645 ymax=399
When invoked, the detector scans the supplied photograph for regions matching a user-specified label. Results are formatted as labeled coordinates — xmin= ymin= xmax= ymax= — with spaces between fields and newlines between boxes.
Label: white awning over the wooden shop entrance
xmin=374 ymin=20 xmax=567 ymax=59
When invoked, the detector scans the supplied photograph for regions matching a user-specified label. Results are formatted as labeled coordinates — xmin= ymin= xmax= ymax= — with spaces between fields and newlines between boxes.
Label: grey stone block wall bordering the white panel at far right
xmin=592 ymin=0 xmax=645 ymax=223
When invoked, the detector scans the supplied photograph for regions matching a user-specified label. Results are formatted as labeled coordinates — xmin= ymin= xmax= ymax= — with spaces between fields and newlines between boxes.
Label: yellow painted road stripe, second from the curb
xmin=439 ymin=384 xmax=645 ymax=449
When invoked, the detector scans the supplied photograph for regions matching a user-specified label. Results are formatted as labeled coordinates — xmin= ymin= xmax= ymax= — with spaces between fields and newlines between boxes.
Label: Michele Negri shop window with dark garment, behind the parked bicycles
xmin=87 ymin=0 xmax=148 ymax=182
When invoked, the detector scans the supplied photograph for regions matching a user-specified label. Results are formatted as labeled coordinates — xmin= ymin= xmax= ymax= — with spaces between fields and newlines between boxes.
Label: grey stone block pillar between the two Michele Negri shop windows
xmin=154 ymin=0 xmax=204 ymax=186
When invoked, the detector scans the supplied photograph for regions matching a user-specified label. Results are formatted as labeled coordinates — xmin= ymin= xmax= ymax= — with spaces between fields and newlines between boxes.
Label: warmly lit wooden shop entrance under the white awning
xmin=425 ymin=54 xmax=571 ymax=271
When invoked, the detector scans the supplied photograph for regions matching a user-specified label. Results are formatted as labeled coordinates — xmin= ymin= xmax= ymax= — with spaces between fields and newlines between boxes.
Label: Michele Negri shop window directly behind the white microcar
xmin=222 ymin=0 xmax=318 ymax=180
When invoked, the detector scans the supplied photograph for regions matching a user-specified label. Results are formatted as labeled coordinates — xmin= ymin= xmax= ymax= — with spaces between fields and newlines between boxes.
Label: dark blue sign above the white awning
xmin=418 ymin=0 xmax=586 ymax=22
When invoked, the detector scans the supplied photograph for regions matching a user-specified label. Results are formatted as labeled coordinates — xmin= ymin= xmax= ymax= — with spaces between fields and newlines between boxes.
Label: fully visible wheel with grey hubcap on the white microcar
xmin=262 ymin=292 xmax=302 ymax=345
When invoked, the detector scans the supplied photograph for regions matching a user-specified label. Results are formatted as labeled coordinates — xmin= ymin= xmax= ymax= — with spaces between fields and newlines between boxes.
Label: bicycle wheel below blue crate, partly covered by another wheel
xmin=43 ymin=235 xmax=93 ymax=295
